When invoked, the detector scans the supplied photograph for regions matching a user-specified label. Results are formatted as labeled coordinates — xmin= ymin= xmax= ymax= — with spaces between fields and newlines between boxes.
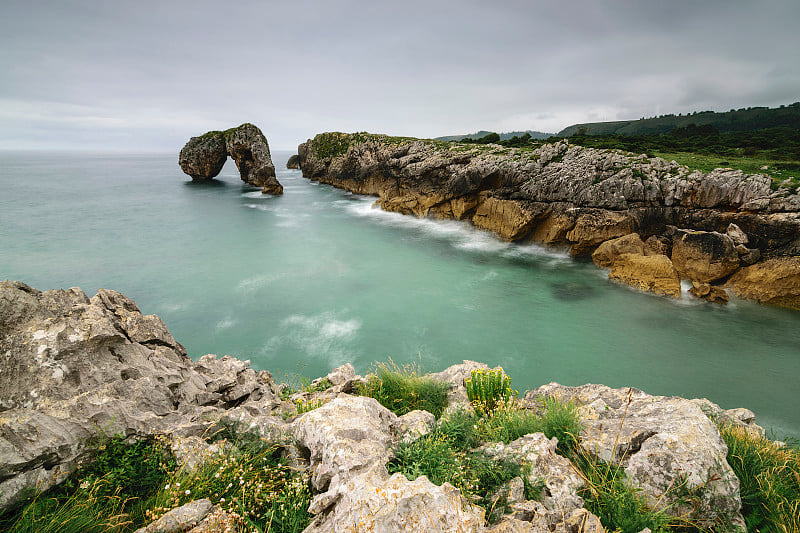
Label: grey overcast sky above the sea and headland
xmin=0 ymin=0 xmax=800 ymax=152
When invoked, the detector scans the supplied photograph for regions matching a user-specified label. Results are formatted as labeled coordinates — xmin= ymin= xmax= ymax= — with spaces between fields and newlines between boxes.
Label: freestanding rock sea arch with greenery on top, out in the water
xmin=178 ymin=124 xmax=283 ymax=194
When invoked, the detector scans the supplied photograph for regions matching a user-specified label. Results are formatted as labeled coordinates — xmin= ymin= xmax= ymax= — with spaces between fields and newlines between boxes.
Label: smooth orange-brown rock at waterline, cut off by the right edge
xmin=725 ymin=257 xmax=800 ymax=310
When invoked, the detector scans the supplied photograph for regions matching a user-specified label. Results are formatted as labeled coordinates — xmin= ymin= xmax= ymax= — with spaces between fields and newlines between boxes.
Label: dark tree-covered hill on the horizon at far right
xmin=558 ymin=102 xmax=800 ymax=137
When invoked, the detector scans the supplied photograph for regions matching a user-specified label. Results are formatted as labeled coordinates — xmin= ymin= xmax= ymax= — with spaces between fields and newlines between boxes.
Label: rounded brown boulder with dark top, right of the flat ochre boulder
xmin=672 ymin=229 xmax=739 ymax=283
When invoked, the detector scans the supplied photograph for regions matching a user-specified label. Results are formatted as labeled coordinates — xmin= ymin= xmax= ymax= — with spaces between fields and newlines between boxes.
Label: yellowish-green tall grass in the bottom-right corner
xmin=720 ymin=425 xmax=800 ymax=533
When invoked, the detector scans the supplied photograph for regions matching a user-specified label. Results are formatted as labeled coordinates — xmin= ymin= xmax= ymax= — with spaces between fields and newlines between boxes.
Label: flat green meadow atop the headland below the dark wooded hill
xmin=653 ymin=151 xmax=800 ymax=192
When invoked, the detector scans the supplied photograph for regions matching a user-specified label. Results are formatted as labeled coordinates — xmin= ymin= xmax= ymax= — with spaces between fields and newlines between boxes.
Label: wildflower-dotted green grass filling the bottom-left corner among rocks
xmin=0 ymin=424 xmax=311 ymax=533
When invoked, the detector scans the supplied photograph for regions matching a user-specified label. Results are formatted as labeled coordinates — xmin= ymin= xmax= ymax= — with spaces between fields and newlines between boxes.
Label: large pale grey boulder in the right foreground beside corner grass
xmin=525 ymin=383 xmax=744 ymax=527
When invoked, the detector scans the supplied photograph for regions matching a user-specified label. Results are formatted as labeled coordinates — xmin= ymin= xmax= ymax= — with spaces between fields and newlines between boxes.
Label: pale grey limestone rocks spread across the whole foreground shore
xmin=0 ymin=280 xmax=780 ymax=533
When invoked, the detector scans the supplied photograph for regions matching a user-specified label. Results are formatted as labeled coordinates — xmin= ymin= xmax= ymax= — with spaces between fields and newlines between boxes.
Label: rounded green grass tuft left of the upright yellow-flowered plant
xmin=358 ymin=360 xmax=449 ymax=418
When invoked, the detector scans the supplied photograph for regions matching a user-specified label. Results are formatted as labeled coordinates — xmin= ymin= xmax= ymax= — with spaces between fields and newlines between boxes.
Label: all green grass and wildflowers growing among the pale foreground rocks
xmin=0 ymin=360 xmax=800 ymax=533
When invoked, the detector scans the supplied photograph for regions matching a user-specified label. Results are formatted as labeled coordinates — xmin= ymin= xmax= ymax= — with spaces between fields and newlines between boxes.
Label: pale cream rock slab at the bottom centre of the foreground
xmin=305 ymin=465 xmax=484 ymax=533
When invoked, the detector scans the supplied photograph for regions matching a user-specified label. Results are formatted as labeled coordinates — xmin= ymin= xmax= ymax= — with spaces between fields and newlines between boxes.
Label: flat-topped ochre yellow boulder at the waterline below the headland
xmin=608 ymin=254 xmax=681 ymax=298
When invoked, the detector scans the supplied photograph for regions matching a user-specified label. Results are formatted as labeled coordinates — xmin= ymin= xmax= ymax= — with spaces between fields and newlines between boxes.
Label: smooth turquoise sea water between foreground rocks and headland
xmin=0 ymin=152 xmax=800 ymax=437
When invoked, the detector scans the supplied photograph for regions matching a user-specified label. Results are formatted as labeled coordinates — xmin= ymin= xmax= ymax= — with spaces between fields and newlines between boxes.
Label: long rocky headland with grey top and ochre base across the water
xmin=297 ymin=132 xmax=800 ymax=309
